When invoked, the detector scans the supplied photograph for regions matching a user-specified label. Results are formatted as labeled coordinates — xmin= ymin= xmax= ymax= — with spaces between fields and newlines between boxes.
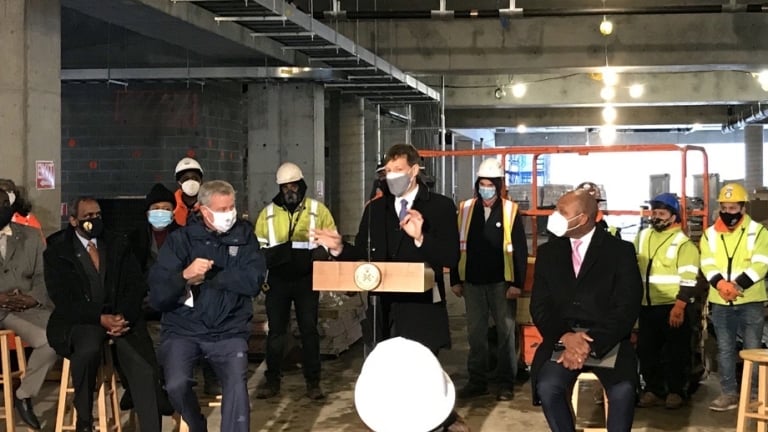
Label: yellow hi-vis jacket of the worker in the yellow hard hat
xmin=700 ymin=214 xmax=768 ymax=305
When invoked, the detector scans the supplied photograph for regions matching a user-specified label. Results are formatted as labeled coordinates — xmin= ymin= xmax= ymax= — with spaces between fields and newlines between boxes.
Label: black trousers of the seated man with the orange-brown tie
xmin=69 ymin=325 xmax=162 ymax=432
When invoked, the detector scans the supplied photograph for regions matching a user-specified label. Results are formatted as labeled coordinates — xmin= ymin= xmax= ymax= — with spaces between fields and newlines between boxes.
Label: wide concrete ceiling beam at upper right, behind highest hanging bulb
xmin=334 ymin=13 xmax=768 ymax=74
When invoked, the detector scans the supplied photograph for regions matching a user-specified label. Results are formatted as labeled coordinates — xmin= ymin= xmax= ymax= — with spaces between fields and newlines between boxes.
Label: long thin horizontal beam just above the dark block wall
xmin=61 ymin=67 xmax=345 ymax=82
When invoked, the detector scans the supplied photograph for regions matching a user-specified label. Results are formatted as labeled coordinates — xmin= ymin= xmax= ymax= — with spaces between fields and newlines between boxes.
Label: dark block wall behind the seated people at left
xmin=61 ymin=83 xmax=247 ymax=228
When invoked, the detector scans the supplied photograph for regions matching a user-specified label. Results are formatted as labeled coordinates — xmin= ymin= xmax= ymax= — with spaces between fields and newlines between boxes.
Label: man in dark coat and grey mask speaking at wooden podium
xmin=314 ymin=144 xmax=459 ymax=354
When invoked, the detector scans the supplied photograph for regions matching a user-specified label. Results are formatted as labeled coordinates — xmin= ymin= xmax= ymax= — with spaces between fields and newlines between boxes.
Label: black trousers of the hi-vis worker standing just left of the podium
xmin=264 ymin=274 xmax=320 ymax=383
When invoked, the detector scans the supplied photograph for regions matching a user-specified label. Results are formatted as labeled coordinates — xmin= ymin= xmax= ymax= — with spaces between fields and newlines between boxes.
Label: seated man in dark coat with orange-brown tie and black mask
xmin=43 ymin=197 xmax=161 ymax=432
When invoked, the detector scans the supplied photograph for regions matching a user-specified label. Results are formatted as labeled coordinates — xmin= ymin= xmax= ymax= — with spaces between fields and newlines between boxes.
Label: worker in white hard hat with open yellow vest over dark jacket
xmin=451 ymin=158 xmax=528 ymax=401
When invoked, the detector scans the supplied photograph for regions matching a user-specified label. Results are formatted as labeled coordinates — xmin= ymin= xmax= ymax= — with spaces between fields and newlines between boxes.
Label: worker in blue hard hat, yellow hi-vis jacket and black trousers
xmin=635 ymin=193 xmax=699 ymax=409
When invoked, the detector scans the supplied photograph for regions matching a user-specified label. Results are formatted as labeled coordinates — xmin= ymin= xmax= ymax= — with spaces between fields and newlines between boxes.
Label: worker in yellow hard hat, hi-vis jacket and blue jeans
xmin=700 ymin=183 xmax=768 ymax=411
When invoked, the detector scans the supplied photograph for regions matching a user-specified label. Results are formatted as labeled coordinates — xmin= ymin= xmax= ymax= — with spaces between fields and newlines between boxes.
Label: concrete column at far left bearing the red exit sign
xmin=0 ymin=0 xmax=63 ymax=234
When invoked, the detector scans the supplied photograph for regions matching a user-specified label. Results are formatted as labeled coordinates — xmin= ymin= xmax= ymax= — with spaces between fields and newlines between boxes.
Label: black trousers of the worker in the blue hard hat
xmin=637 ymin=305 xmax=691 ymax=397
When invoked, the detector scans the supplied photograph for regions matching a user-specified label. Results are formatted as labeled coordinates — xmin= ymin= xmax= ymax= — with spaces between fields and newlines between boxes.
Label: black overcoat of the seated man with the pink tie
xmin=531 ymin=228 xmax=643 ymax=403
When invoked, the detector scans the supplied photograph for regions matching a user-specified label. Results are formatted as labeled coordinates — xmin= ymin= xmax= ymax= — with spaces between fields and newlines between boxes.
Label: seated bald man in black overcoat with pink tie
xmin=531 ymin=190 xmax=643 ymax=432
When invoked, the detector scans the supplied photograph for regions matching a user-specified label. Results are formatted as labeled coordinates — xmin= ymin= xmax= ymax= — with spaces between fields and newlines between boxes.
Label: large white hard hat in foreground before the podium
xmin=355 ymin=337 xmax=456 ymax=432
